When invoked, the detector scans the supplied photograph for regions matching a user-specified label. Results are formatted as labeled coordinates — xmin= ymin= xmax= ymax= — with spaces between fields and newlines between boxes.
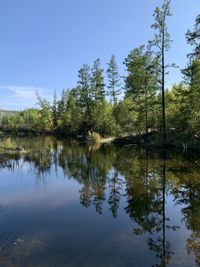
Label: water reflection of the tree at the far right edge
xmin=171 ymin=160 xmax=200 ymax=266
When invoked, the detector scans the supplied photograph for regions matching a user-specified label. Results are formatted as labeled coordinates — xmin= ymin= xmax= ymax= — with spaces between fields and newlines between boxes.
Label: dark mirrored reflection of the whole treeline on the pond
xmin=0 ymin=137 xmax=200 ymax=267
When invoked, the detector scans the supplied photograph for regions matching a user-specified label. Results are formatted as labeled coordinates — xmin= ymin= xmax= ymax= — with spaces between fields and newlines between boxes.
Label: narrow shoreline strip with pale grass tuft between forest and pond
xmin=0 ymin=132 xmax=200 ymax=154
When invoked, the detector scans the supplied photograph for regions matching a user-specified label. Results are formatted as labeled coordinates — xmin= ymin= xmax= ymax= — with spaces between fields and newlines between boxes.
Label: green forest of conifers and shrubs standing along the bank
xmin=0 ymin=0 xmax=200 ymax=149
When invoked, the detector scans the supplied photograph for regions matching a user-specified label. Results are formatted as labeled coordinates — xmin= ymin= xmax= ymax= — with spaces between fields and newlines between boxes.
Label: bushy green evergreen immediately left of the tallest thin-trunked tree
xmin=124 ymin=45 xmax=157 ymax=137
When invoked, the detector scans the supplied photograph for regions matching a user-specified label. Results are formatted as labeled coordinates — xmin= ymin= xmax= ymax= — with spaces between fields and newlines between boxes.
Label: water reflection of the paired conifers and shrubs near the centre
xmin=59 ymin=143 xmax=113 ymax=214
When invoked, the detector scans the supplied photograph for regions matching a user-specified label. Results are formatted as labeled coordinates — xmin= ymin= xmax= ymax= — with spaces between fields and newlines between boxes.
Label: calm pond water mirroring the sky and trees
xmin=0 ymin=138 xmax=200 ymax=267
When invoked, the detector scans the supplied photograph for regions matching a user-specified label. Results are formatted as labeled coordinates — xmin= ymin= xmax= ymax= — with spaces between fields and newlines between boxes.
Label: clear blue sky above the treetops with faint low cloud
xmin=0 ymin=0 xmax=200 ymax=110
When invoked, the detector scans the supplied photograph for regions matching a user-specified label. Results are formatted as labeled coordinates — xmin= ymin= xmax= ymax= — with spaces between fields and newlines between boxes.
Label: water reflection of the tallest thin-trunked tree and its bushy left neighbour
xmin=117 ymin=151 xmax=177 ymax=266
